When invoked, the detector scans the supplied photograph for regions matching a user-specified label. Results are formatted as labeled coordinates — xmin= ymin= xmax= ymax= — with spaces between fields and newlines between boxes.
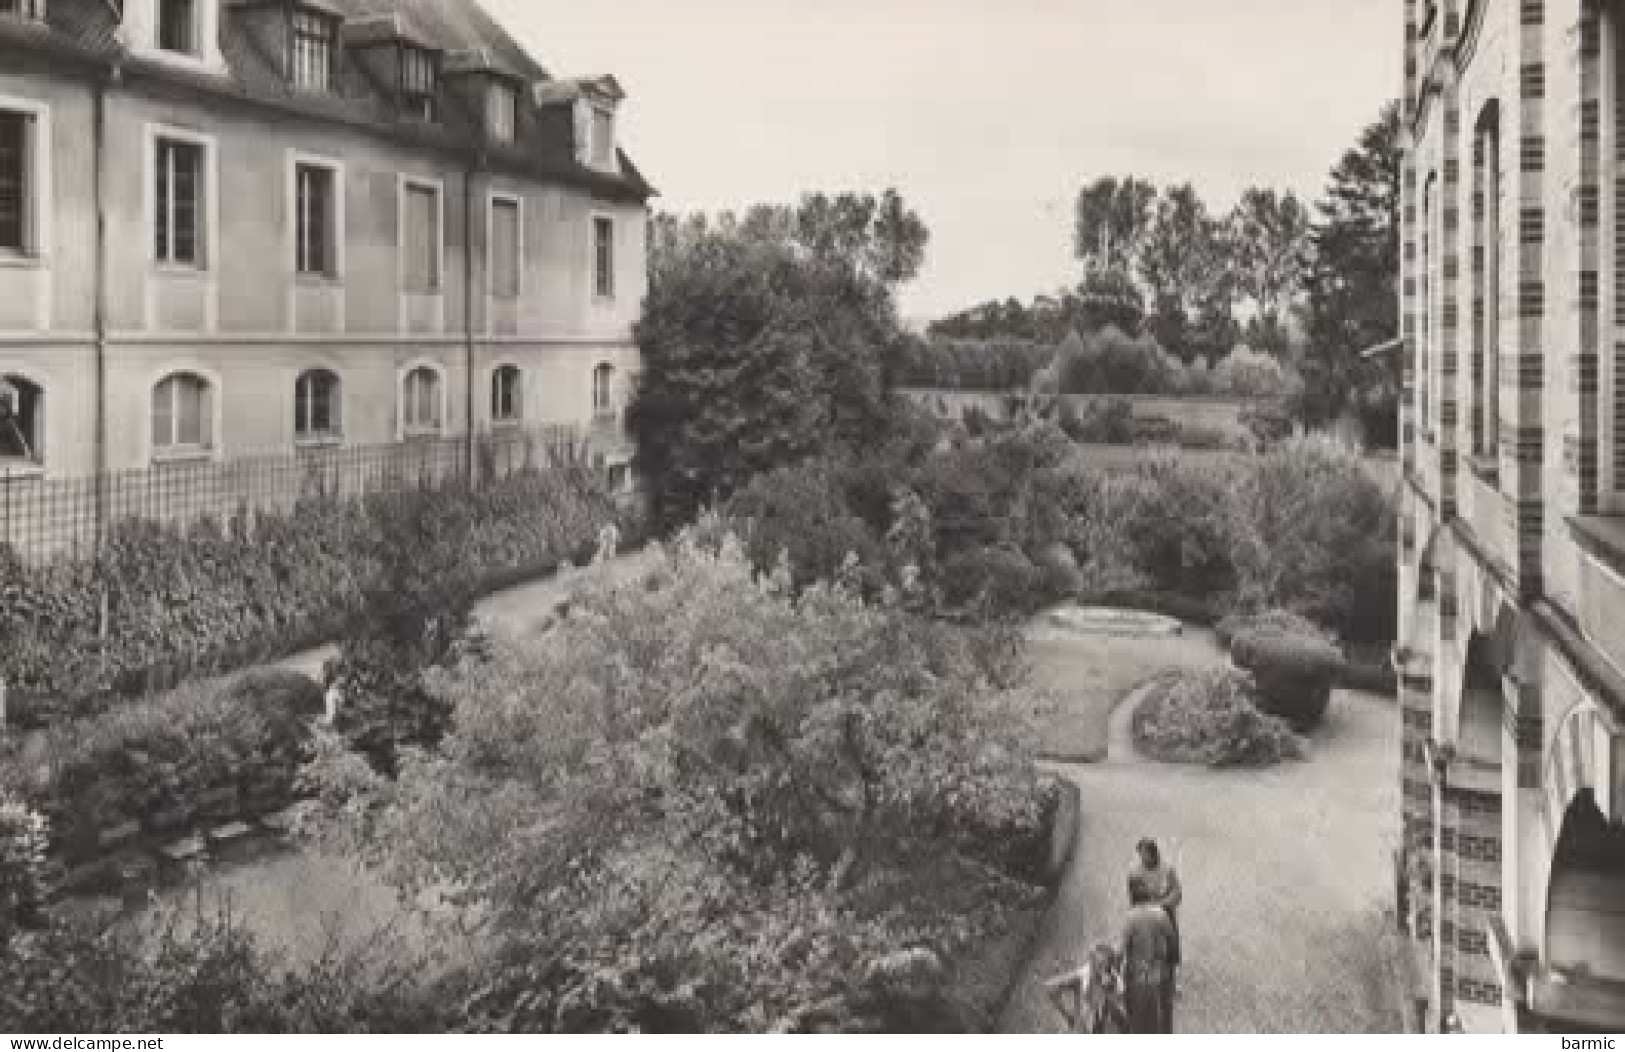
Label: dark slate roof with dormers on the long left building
xmin=0 ymin=0 xmax=655 ymax=202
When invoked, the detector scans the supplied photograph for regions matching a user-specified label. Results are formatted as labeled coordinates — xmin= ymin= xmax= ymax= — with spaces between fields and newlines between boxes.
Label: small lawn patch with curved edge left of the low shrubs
xmin=1030 ymin=628 xmax=1224 ymax=763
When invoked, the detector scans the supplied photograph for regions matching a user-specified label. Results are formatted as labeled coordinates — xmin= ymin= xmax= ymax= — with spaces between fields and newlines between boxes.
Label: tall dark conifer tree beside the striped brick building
xmin=1302 ymin=102 xmax=1399 ymax=441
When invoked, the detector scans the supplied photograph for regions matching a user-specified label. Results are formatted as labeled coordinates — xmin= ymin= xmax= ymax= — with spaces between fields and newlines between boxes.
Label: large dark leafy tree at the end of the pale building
xmin=629 ymin=193 xmax=928 ymax=527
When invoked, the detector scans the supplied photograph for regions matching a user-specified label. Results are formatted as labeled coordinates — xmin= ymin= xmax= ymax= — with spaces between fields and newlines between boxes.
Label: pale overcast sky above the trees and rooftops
xmin=484 ymin=0 xmax=1402 ymax=319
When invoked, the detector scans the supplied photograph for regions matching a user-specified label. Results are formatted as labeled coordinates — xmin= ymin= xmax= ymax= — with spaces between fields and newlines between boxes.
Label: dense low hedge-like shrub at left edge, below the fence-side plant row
xmin=0 ymin=673 xmax=322 ymax=862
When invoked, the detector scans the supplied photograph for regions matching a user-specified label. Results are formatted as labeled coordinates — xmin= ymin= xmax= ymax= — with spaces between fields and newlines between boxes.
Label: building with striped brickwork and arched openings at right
xmin=1396 ymin=0 xmax=1625 ymax=1032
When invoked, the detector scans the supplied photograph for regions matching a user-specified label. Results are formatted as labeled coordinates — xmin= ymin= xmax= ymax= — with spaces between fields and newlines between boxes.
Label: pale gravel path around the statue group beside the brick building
xmin=999 ymin=634 xmax=1401 ymax=1032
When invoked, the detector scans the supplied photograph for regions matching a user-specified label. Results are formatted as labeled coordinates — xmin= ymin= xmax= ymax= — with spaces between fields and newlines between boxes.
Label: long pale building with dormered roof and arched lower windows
xmin=0 ymin=0 xmax=652 ymax=489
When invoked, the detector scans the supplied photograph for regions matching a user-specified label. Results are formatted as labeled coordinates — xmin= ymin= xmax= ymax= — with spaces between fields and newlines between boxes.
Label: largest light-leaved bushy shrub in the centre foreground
xmin=305 ymin=538 xmax=1050 ymax=1032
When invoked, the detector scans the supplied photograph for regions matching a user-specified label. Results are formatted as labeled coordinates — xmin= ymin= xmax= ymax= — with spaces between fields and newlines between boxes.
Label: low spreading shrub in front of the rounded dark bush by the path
xmin=1133 ymin=668 xmax=1307 ymax=767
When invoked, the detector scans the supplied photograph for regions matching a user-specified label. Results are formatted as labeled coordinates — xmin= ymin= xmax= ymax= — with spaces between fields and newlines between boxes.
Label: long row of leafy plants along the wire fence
xmin=0 ymin=467 xmax=627 ymax=727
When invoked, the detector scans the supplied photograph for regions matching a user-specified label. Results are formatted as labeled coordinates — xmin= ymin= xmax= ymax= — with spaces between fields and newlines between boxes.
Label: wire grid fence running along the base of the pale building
xmin=0 ymin=424 xmax=600 ymax=564
